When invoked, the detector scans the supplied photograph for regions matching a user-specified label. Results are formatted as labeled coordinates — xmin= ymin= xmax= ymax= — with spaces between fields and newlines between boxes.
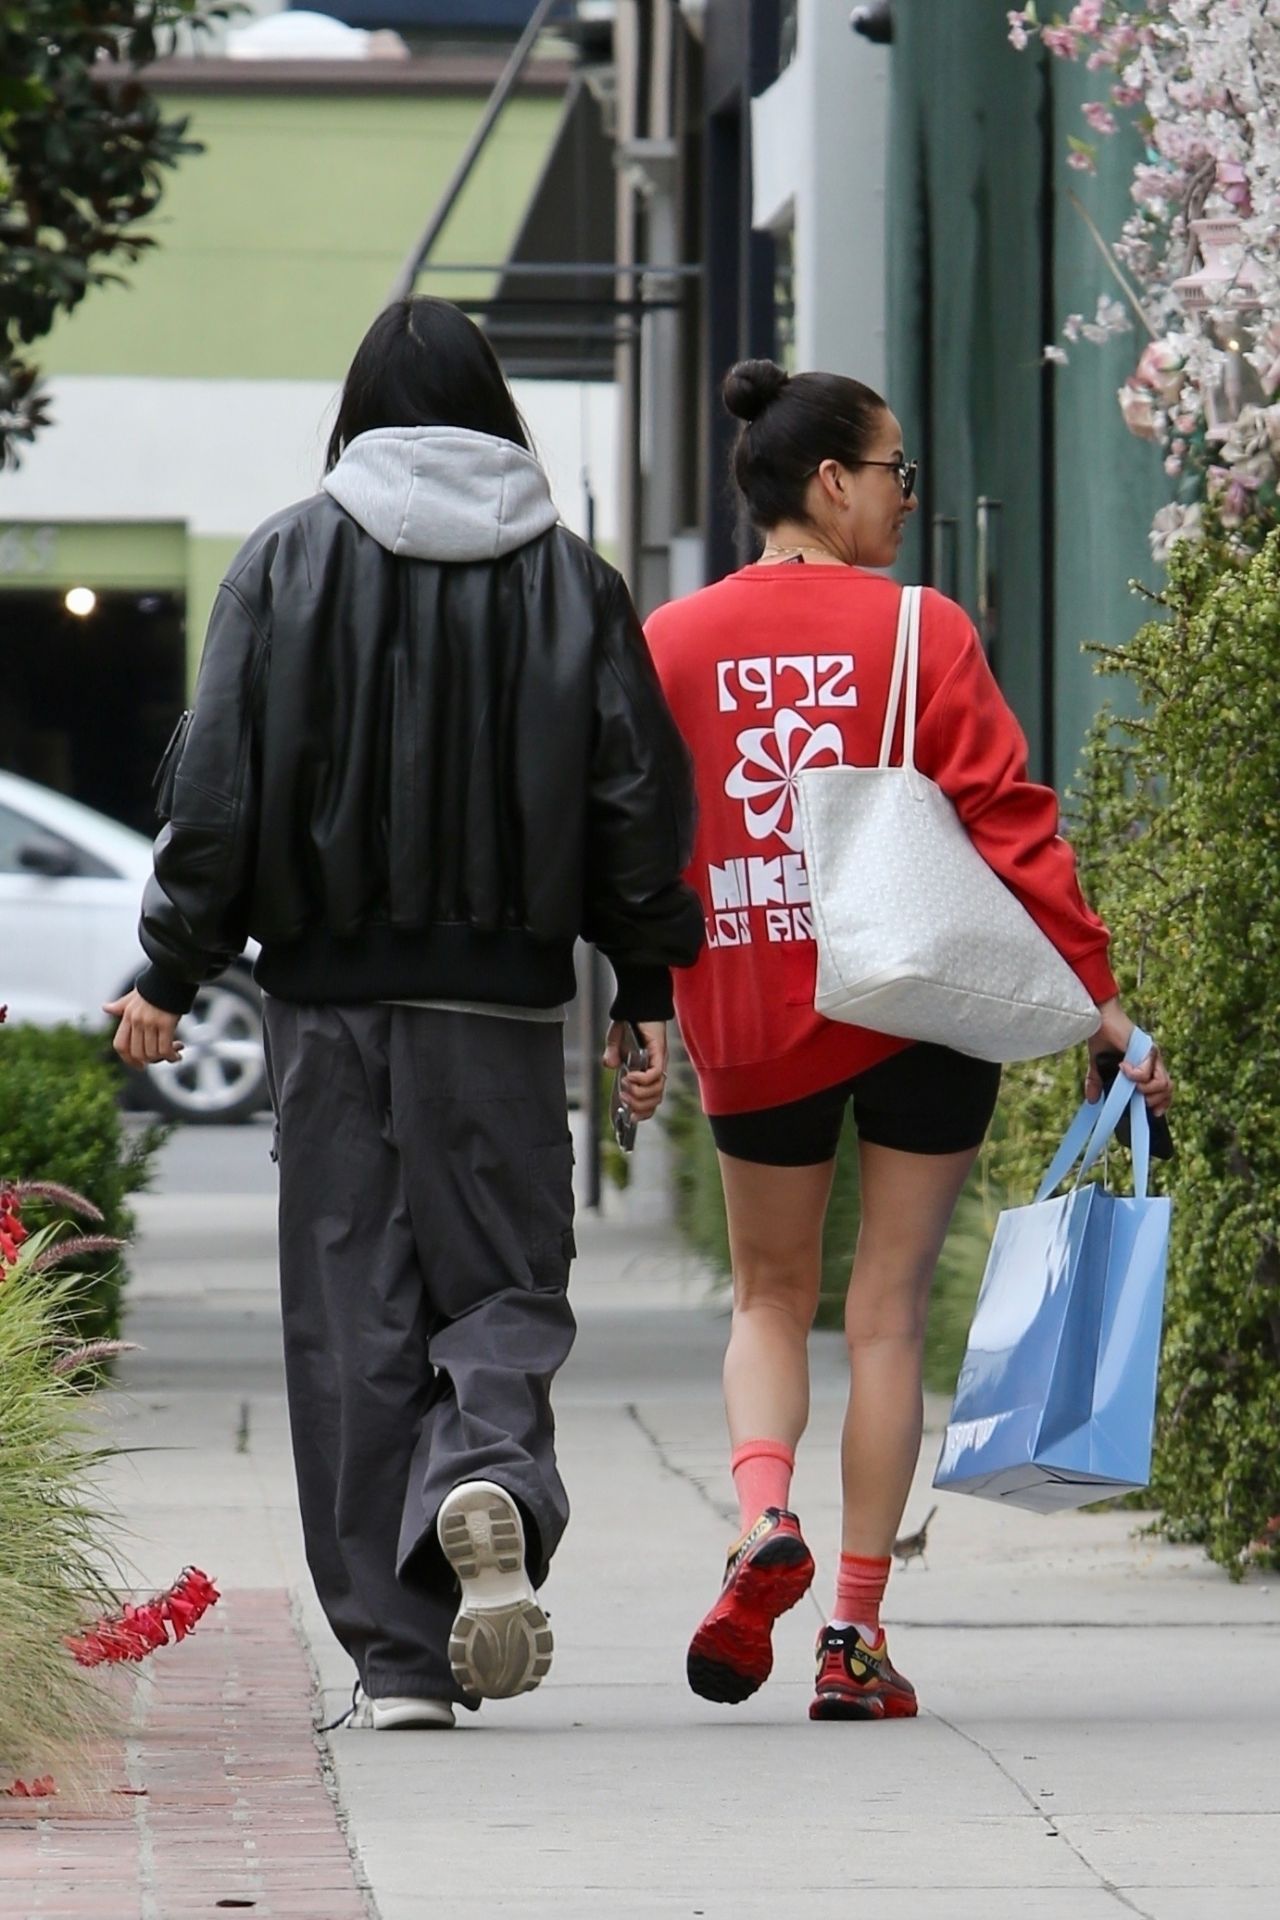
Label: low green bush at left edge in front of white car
xmin=0 ymin=1025 xmax=167 ymax=1340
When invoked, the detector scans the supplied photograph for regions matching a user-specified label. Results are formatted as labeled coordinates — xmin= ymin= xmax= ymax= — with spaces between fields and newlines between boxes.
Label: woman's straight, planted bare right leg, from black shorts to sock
xmin=841 ymin=1142 xmax=977 ymax=1559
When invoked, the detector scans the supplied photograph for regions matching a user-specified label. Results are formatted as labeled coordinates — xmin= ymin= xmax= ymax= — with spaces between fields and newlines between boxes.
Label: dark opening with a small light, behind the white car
xmin=0 ymin=588 xmax=186 ymax=837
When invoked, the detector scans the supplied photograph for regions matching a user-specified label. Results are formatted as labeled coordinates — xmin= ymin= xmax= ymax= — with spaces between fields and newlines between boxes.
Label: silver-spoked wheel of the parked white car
xmin=140 ymin=973 xmax=269 ymax=1127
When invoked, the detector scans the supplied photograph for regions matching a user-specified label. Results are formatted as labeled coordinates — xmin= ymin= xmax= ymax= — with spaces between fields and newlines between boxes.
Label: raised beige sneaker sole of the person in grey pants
xmin=436 ymin=1480 xmax=551 ymax=1699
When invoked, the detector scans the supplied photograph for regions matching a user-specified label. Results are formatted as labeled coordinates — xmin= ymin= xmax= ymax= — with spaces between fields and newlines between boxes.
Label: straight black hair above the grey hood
xmin=324 ymin=294 xmax=530 ymax=472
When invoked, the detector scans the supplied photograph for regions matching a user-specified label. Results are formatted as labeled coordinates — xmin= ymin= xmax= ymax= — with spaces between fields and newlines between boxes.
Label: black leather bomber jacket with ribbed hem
xmin=138 ymin=493 xmax=704 ymax=1020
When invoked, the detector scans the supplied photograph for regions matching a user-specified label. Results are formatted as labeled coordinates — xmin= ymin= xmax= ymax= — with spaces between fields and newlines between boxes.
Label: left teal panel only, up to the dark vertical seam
xmin=889 ymin=0 xmax=1044 ymax=756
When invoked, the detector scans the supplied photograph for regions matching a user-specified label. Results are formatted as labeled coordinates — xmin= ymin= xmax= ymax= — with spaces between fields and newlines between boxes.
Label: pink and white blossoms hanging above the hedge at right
xmin=1007 ymin=0 xmax=1280 ymax=559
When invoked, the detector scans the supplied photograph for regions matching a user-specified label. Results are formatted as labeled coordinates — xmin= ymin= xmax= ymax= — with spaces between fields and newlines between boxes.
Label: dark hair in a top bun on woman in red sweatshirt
xmin=720 ymin=361 xmax=885 ymax=532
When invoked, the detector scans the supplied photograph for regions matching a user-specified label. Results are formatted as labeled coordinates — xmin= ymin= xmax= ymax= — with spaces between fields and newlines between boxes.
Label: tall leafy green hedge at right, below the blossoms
xmin=992 ymin=536 xmax=1280 ymax=1572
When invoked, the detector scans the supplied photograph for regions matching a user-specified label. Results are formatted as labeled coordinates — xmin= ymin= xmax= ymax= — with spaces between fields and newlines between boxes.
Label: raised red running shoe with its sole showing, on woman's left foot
xmin=687 ymin=1507 xmax=814 ymax=1705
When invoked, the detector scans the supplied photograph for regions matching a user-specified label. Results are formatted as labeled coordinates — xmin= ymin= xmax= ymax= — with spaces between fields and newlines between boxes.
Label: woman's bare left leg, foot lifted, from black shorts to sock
xmin=720 ymin=1154 xmax=835 ymax=1448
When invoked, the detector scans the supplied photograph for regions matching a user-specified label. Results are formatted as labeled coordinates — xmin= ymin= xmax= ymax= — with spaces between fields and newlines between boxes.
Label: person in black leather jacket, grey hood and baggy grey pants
xmin=109 ymin=300 xmax=702 ymax=1728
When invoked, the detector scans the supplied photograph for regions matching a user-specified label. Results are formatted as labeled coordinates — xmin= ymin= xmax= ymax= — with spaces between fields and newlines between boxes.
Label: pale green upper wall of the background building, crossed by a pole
xmin=42 ymin=94 xmax=562 ymax=380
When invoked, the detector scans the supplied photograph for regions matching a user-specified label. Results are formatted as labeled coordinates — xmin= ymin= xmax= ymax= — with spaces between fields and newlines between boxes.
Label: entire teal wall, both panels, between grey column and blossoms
xmin=887 ymin=0 xmax=1167 ymax=785
